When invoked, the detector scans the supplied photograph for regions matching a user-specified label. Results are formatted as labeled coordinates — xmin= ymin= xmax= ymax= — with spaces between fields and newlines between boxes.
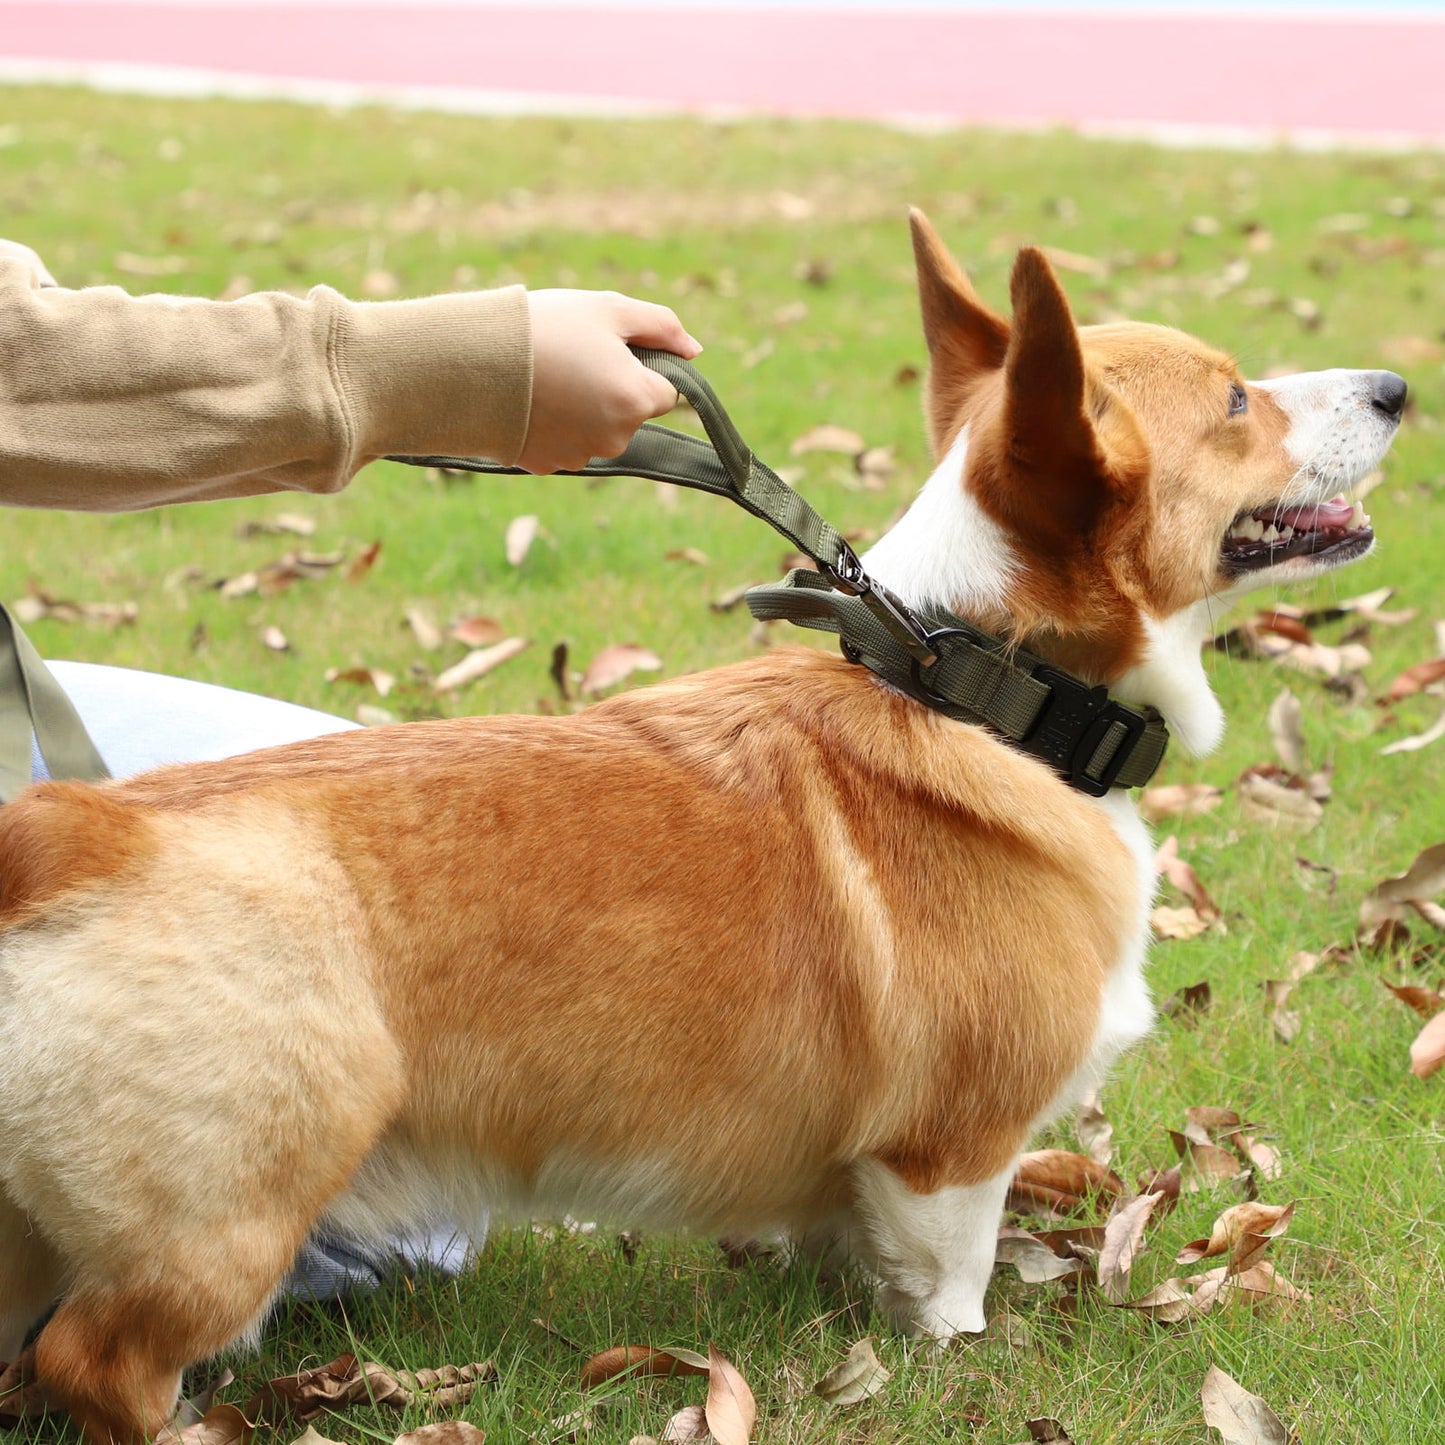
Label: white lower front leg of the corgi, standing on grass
xmin=855 ymin=1159 xmax=1014 ymax=1340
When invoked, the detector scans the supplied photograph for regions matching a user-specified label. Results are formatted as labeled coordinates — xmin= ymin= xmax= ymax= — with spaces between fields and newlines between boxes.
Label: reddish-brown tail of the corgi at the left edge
xmin=0 ymin=783 xmax=153 ymax=928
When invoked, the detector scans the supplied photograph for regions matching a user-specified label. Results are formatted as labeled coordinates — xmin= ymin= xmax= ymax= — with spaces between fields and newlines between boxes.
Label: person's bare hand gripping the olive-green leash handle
xmin=517 ymin=290 xmax=702 ymax=473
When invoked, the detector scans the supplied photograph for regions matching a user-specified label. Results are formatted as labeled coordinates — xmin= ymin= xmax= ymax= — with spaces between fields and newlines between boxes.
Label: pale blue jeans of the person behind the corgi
xmin=32 ymin=662 xmax=486 ymax=1299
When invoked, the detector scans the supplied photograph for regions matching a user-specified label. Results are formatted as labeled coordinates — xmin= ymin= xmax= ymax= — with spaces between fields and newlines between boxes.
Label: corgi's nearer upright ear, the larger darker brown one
xmin=998 ymin=247 xmax=1150 ymax=548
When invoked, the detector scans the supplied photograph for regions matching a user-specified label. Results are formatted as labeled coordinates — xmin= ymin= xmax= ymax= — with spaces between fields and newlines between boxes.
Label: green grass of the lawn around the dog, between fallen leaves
xmin=0 ymin=88 xmax=1445 ymax=1445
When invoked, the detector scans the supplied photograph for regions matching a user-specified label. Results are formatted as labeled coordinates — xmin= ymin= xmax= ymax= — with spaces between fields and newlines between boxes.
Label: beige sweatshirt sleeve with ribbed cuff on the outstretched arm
xmin=0 ymin=243 xmax=532 ymax=512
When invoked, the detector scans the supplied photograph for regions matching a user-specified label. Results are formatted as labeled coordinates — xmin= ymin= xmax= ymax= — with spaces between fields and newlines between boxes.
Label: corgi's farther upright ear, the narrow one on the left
xmin=909 ymin=208 xmax=1009 ymax=457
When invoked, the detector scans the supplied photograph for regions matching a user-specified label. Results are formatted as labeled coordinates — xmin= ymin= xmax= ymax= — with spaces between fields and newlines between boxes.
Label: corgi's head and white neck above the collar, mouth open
xmin=870 ymin=212 xmax=1406 ymax=749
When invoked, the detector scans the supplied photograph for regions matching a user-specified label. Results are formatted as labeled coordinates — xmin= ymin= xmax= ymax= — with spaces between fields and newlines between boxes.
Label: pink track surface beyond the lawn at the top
xmin=0 ymin=0 xmax=1445 ymax=140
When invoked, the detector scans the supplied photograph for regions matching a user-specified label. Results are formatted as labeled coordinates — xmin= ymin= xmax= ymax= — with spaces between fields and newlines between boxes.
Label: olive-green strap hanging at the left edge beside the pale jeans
xmin=0 ymin=607 xmax=110 ymax=803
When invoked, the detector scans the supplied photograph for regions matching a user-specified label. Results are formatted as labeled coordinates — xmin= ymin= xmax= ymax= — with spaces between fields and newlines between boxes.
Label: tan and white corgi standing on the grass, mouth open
xmin=0 ymin=214 xmax=1406 ymax=1445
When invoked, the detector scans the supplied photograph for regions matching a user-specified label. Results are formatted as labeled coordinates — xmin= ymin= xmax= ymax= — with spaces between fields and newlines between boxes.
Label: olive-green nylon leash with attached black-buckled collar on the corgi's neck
xmin=387 ymin=347 xmax=1169 ymax=796
